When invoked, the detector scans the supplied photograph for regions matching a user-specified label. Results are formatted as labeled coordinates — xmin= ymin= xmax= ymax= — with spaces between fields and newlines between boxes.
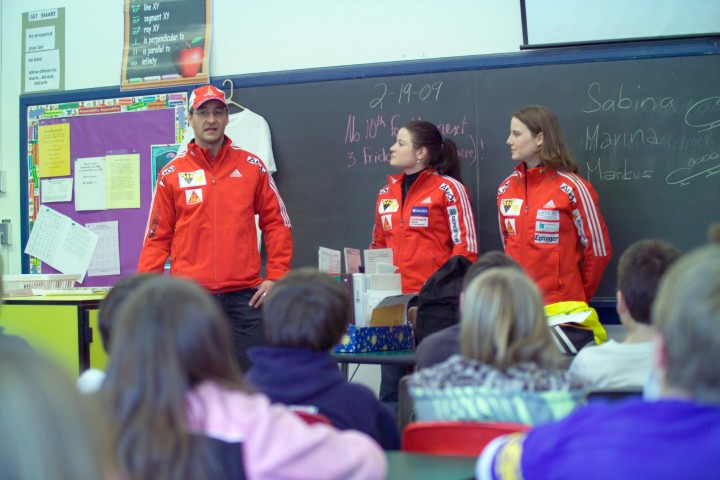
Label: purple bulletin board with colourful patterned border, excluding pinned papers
xmin=21 ymin=90 xmax=187 ymax=287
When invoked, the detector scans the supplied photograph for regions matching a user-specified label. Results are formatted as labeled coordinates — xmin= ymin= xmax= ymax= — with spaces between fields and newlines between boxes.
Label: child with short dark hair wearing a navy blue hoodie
xmin=247 ymin=268 xmax=400 ymax=450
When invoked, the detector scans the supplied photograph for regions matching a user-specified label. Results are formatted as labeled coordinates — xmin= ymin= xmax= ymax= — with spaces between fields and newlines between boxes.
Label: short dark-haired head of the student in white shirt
xmin=618 ymin=239 xmax=680 ymax=324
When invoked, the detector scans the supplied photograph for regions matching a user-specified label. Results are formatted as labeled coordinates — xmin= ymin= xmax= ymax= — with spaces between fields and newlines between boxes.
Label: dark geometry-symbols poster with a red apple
xmin=120 ymin=0 xmax=211 ymax=90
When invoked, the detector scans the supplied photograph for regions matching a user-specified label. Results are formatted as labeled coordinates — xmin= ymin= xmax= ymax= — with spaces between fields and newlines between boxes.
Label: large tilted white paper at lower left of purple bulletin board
xmin=25 ymin=205 xmax=98 ymax=283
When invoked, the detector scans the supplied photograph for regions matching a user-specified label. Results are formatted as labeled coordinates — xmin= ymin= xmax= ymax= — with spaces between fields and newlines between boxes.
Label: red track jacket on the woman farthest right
xmin=497 ymin=163 xmax=612 ymax=304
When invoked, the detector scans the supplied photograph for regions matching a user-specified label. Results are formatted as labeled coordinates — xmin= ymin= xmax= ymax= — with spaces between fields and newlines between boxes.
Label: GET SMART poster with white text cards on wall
xmin=21 ymin=8 xmax=65 ymax=93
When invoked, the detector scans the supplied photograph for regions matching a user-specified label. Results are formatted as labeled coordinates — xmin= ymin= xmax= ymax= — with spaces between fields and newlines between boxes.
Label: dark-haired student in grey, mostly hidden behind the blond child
xmin=415 ymin=251 xmax=520 ymax=370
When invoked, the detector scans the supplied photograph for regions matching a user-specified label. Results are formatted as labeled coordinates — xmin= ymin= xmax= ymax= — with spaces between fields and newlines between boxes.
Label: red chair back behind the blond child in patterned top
xmin=400 ymin=420 xmax=530 ymax=457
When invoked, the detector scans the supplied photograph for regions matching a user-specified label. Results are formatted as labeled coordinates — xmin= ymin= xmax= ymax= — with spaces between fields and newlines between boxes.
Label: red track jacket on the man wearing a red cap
xmin=138 ymin=136 xmax=292 ymax=292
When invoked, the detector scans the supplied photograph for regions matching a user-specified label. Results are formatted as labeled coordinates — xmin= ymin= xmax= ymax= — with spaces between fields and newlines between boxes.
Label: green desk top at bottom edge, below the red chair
xmin=385 ymin=450 xmax=477 ymax=480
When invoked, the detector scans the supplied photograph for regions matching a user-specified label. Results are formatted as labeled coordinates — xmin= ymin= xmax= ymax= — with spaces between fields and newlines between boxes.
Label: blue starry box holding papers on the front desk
xmin=335 ymin=324 xmax=415 ymax=353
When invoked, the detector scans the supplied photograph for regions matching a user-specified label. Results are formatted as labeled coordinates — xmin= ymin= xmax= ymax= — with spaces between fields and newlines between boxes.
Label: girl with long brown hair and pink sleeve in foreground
xmin=99 ymin=277 xmax=386 ymax=480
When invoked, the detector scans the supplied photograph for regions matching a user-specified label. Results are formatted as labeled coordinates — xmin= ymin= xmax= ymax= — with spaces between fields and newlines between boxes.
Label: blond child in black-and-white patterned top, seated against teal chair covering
xmin=408 ymin=268 xmax=584 ymax=425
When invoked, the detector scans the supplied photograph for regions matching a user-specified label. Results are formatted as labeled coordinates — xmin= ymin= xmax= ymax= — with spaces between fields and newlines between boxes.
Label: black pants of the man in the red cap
xmin=215 ymin=288 xmax=265 ymax=373
